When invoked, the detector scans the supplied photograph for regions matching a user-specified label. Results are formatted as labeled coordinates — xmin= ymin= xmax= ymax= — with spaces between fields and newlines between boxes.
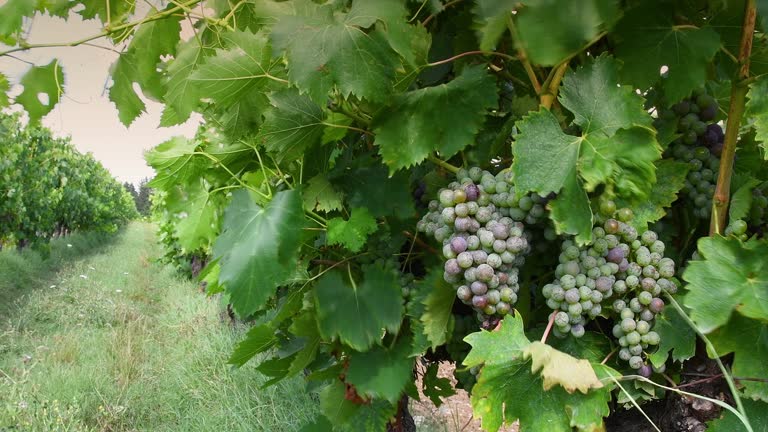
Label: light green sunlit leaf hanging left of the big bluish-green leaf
xmin=166 ymin=179 xmax=216 ymax=252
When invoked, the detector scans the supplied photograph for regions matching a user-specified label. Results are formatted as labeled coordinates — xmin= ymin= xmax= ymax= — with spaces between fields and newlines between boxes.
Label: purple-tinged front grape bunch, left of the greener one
xmin=417 ymin=167 xmax=546 ymax=321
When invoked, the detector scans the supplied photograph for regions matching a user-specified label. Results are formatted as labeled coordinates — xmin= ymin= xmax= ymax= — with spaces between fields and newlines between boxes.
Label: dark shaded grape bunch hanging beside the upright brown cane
xmin=658 ymin=90 xmax=724 ymax=219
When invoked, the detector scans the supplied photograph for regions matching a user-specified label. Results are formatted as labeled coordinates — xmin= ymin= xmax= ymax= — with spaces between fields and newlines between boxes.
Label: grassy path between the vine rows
xmin=0 ymin=223 xmax=317 ymax=432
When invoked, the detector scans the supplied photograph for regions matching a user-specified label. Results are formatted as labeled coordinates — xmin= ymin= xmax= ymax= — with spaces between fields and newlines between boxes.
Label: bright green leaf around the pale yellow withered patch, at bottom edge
xmin=464 ymin=314 xmax=620 ymax=432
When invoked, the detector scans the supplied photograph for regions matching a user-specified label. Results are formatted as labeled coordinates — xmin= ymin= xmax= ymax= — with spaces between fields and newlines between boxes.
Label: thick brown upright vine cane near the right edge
xmin=709 ymin=0 xmax=757 ymax=235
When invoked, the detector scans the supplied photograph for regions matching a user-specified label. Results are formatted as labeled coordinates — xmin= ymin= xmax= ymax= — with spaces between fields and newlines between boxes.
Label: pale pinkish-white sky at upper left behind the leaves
xmin=0 ymin=4 xmax=200 ymax=183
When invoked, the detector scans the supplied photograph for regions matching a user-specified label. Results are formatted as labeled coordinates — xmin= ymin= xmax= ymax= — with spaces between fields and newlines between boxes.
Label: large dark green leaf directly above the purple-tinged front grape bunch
xmin=371 ymin=66 xmax=497 ymax=173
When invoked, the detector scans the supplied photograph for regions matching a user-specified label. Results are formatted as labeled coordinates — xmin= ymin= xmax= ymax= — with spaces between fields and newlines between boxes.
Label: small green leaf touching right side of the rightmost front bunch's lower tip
xmin=648 ymin=307 xmax=696 ymax=367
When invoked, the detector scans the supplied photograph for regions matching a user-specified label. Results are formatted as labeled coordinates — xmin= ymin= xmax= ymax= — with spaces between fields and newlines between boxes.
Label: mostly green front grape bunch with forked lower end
xmin=542 ymin=201 xmax=677 ymax=376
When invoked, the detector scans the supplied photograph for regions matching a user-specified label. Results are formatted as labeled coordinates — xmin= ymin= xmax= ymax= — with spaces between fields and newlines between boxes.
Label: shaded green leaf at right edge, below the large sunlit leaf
xmin=709 ymin=314 xmax=768 ymax=402
